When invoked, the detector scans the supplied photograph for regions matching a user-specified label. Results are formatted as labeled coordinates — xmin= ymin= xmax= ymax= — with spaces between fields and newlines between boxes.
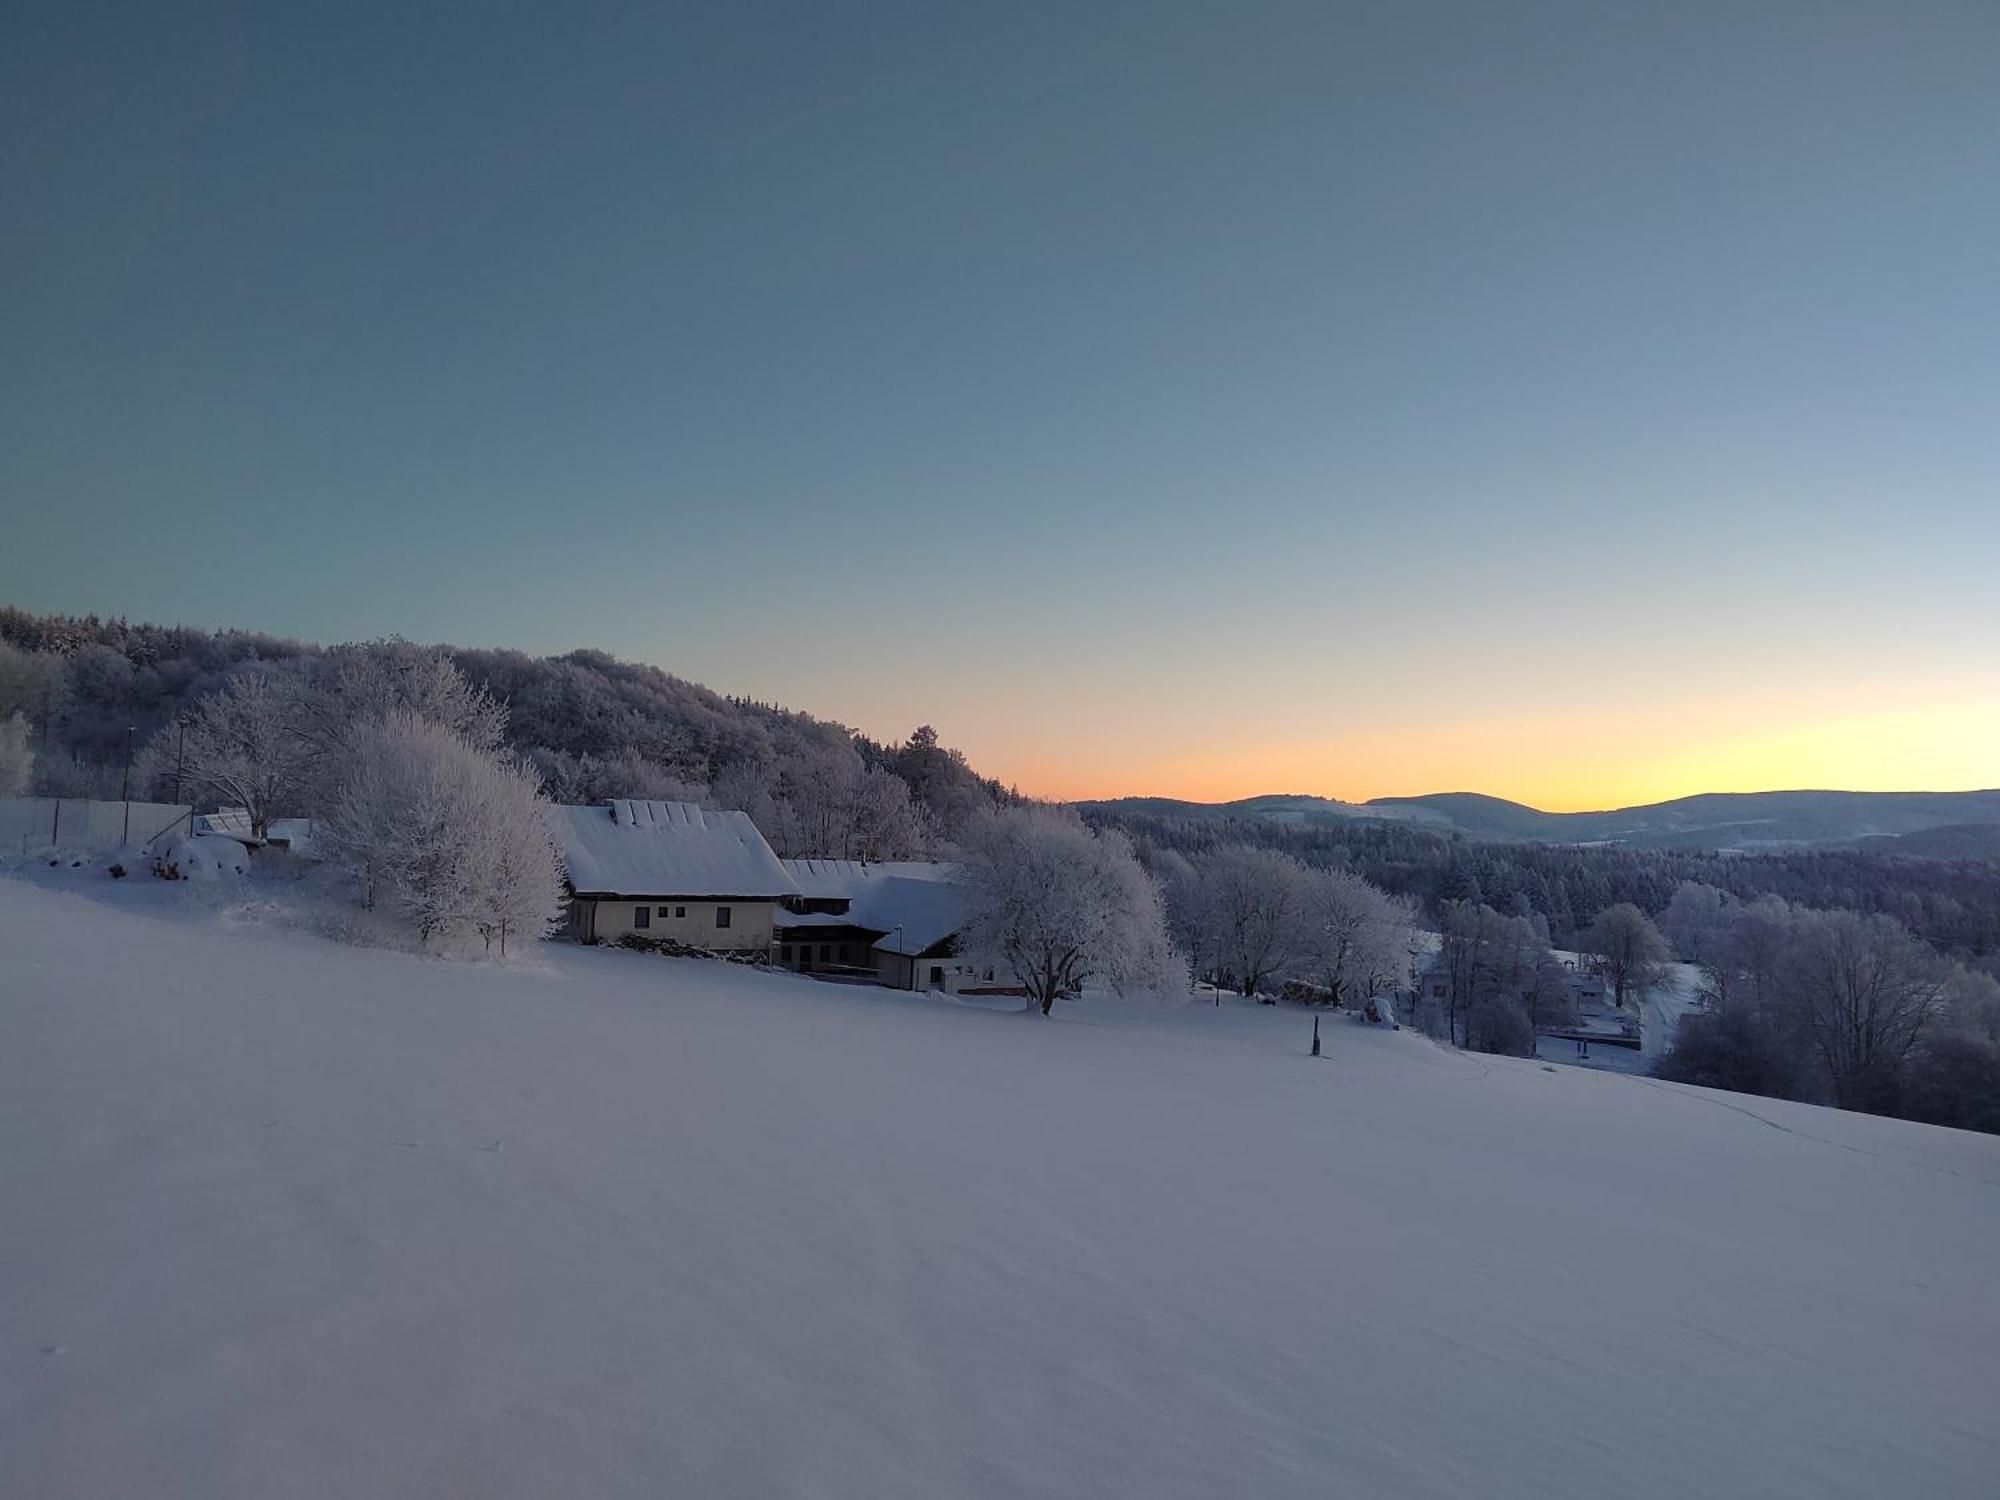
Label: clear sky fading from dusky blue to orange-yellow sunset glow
xmin=0 ymin=0 xmax=2000 ymax=808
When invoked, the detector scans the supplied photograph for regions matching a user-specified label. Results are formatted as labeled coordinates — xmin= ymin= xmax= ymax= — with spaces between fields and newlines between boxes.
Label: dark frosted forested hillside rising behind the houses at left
xmin=0 ymin=608 xmax=1014 ymax=858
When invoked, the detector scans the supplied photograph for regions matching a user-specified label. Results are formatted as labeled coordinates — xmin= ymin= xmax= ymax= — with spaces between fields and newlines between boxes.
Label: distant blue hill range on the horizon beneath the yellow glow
xmin=1092 ymin=790 xmax=2000 ymax=858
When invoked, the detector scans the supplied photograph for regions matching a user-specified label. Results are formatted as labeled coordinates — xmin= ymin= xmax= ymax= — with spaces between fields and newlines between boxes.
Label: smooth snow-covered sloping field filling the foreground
xmin=0 ymin=880 xmax=2000 ymax=1500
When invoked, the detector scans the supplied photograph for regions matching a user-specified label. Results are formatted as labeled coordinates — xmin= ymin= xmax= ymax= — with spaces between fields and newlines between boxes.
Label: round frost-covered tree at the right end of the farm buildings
xmin=960 ymin=806 xmax=1188 ymax=1016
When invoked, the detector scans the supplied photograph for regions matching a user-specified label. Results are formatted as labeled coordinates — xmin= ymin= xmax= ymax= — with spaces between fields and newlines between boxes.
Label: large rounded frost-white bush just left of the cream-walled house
xmin=322 ymin=710 xmax=562 ymax=948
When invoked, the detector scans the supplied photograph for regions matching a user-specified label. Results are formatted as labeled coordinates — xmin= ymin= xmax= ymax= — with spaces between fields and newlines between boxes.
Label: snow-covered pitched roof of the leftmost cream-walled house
xmin=554 ymin=798 xmax=798 ymax=900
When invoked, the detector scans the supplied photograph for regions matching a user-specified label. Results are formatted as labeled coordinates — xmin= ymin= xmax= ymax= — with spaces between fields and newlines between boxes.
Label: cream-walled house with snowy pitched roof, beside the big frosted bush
xmin=554 ymin=798 xmax=798 ymax=952
